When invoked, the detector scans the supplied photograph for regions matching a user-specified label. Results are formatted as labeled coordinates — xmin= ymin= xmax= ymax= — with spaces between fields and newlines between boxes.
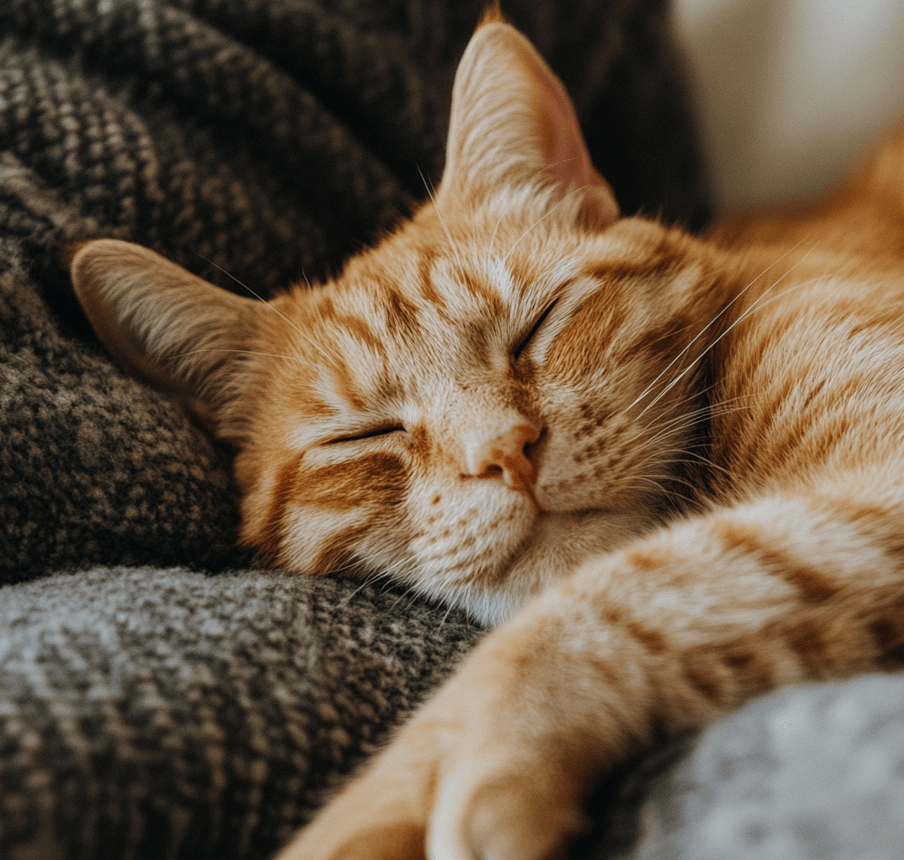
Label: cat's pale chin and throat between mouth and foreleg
xmin=444 ymin=504 xmax=655 ymax=626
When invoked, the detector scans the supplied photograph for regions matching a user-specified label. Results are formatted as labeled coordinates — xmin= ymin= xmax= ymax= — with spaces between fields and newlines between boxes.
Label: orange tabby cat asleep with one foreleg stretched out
xmin=72 ymin=6 xmax=904 ymax=860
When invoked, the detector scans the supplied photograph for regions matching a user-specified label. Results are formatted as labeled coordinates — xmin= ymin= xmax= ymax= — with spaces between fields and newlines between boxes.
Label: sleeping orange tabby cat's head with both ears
xmin=72 ymin=22 xmax=717 ymax=621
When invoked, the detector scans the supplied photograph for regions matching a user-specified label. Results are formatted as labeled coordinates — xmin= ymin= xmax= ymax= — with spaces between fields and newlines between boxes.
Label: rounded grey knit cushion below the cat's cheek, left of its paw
xmin=0 ymin=568 xmax=476 ymax=860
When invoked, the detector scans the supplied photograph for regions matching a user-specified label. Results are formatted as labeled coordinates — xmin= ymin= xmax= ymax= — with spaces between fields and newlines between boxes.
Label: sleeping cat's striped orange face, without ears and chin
xmin=238 ymin=201 xmax=720 ymax=617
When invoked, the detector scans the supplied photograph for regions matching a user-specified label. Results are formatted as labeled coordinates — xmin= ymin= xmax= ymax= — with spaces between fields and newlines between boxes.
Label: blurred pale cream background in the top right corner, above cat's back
xmin=673 ymin=0 xmax=904 ymax=210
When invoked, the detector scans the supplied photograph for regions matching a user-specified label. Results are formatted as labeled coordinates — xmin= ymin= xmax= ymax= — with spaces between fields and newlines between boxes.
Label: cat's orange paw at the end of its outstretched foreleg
xmin=279 ymin=612 xmax=605 ymax=860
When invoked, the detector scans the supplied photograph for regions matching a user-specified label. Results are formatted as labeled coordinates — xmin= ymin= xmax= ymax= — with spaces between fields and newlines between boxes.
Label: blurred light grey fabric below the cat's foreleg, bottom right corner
xmin=586 ymin=674 xmax=904 ymax=860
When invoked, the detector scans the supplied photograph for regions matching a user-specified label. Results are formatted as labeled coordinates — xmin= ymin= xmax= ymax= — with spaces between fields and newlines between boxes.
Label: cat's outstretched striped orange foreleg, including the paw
xmin=281 ymin=473 xmax=904 ymax=860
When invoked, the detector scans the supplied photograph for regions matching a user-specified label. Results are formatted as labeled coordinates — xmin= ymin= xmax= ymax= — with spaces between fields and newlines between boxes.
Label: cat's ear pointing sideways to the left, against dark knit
xmin=70 ymin=239 xmax=261 ymax=437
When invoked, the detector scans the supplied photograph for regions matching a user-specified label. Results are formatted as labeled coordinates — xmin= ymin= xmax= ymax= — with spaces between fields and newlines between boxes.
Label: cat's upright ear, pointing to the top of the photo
xmin=438 ymin=20 xmax=619 ymax=228
